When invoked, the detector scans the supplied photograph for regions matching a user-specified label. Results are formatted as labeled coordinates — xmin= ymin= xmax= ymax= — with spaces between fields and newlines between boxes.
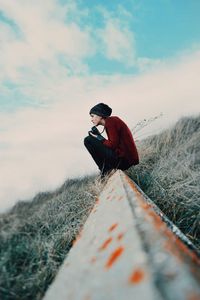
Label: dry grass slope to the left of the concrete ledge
xmin=0 ymin=176 xmax=106 ymax=300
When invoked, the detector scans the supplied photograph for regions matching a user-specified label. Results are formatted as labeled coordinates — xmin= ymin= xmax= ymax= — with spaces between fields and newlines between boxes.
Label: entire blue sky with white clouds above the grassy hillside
xmin=0 ymin=0 xmax=200 ymax=212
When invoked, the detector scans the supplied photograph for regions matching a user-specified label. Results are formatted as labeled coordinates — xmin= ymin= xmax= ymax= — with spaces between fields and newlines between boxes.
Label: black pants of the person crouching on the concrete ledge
xmin=84 ymin=135 xmax=130 ymax=175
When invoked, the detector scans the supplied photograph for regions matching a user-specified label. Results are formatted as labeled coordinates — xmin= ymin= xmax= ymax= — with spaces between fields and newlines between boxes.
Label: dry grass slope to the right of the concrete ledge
xmin=126 ymin=115 xmax=200 ymax=248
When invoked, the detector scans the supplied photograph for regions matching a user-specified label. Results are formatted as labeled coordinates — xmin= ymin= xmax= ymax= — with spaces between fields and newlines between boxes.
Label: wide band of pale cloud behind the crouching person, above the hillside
xmin=0 ymin=52 xmax=200 ymax=211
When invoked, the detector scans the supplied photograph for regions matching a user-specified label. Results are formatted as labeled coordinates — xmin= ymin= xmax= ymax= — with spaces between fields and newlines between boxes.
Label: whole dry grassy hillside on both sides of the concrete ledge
xmin=0 ymin=116 xmax=200 ymax=300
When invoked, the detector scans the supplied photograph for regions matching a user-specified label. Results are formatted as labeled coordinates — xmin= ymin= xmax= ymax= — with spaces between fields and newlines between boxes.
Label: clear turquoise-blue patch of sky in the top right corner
xmin=82 ymin=0 xmax=200 ymax=59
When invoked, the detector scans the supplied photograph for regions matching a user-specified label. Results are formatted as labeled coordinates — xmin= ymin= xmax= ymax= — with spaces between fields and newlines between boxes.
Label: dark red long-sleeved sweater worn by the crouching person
xmin=103 ymin=116 xmax=139 ymax=166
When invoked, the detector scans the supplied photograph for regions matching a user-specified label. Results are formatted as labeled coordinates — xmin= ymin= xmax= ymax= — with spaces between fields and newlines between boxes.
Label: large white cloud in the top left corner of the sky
xmin=0 ymin=0 xmax=95 ymax=80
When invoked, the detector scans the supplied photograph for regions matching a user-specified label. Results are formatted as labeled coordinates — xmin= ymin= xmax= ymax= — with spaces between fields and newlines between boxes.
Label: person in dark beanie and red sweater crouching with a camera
xmin=84 ymin=103 xmax=139 ymax=178
